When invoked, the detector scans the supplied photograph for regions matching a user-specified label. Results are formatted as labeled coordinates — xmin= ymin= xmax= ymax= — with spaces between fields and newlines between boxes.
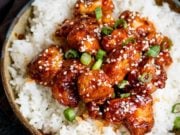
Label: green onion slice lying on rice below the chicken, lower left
xmin=64 ymin=108 xmax=76 ymax=122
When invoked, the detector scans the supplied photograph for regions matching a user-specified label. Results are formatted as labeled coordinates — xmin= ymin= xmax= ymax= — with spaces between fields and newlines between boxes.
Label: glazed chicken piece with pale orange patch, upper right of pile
xmin=119 ymin=10 xmax=156 ymax=37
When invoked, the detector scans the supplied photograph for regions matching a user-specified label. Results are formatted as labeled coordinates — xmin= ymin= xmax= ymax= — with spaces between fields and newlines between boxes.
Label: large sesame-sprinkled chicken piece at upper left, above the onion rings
xmin=56 ymin=17 xmax=101 ymax=54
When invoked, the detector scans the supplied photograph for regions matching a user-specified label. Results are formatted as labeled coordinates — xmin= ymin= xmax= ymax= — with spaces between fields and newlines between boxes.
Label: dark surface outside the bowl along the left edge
xmin=0 ymin=0 xmax=30 ymax=135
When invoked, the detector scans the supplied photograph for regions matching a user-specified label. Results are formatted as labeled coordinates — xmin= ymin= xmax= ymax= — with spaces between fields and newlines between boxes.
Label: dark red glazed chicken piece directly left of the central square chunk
xmin=52 ymin=60 xmax=88 ymax=107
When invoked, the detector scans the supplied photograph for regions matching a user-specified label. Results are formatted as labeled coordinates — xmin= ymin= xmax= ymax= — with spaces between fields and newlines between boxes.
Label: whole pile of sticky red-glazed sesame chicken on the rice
xmin=27 ymin=0 xmax=172 ymax=135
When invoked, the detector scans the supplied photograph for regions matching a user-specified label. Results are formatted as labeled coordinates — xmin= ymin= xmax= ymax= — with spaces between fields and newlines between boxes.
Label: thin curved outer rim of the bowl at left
xmin=0 ymin=0 xmax=42 ymax=135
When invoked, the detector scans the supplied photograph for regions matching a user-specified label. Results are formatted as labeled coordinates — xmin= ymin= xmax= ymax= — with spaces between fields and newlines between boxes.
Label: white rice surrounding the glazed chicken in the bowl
xmin=9 ymin=0 xmax=180 ymax=135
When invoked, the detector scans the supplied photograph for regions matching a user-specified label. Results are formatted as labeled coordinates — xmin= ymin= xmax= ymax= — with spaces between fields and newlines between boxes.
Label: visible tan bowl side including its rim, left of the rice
xmin=1 ymin=1 xmax=42 ymax=135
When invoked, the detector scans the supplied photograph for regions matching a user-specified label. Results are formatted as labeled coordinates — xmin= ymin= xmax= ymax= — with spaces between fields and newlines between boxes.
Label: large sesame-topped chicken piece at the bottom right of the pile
xmin=104 ymin=94 xmax=154 ymax=135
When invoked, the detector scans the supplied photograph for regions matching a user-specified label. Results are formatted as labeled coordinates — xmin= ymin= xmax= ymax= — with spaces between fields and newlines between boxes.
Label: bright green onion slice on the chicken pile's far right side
xmin=146 ymin=45 xmax=160 ymax=57
